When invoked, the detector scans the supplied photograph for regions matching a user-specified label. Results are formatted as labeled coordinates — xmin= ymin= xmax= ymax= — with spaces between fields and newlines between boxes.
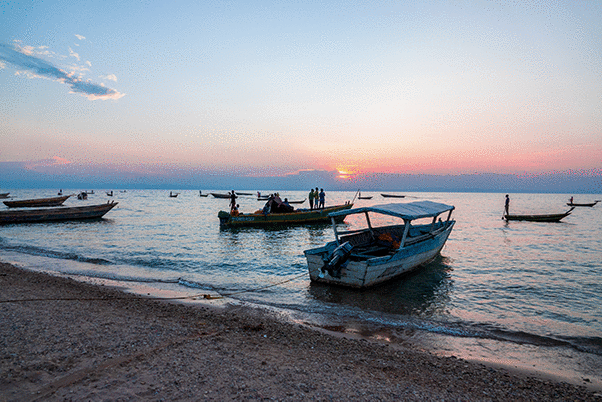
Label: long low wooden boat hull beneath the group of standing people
xmin=217 ymin=202 xmax=353 ymax=227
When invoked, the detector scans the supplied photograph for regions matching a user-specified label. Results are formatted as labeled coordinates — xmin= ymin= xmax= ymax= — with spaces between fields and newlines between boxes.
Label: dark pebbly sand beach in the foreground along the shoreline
xmin=0 ymin=263 xmax=602 ymax=401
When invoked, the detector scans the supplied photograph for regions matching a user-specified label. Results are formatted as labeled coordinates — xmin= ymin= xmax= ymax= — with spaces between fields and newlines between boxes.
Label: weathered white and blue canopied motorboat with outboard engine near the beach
xmin=304 ymin=201 xmax=456 ymax=289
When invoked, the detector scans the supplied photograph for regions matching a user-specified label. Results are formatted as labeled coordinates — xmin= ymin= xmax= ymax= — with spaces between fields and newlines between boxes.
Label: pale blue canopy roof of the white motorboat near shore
xmin=328 ymin=201 xmax=455 ymax=221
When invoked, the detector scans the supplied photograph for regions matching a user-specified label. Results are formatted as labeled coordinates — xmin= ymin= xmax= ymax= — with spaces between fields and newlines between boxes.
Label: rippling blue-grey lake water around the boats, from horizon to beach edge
xmin=0 ymin=189 xmax=602 ymax=385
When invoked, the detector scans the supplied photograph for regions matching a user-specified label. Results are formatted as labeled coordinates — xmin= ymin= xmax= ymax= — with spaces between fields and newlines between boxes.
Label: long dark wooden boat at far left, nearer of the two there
xmin=0 ymin=201 xmax=118 ymax=224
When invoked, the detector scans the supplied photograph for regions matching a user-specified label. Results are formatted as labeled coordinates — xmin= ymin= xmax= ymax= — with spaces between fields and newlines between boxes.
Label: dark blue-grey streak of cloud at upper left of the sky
xmin=0 ymin=43 xmax=125 ymax=100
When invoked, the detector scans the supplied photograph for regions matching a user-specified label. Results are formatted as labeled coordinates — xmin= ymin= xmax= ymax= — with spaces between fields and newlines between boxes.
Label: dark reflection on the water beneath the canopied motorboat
xmin=308 ymin=256 xmax=453 ymax=317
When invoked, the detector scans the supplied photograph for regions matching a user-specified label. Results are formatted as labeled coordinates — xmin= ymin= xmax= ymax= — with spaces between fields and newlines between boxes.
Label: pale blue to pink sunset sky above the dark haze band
xmin=0 ymin=0 xmax=602 ymax=186
